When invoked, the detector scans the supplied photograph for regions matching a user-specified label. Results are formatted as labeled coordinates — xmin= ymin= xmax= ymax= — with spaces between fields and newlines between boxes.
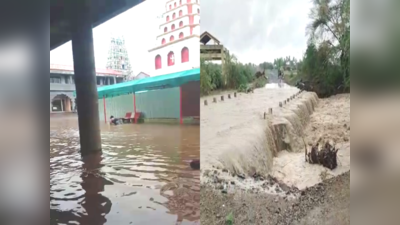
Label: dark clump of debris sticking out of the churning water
xmin=305 ymin=142 xmax=339 ymax=170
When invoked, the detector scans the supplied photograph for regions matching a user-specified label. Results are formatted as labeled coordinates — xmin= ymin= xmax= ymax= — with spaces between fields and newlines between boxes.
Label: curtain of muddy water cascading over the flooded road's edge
xmin=212 ymin=90 xmax=318 ymax=177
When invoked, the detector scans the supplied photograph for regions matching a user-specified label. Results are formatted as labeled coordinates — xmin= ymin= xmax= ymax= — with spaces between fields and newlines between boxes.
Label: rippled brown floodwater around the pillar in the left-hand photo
xmin=50 ymin=114 xmax=200 ymax=225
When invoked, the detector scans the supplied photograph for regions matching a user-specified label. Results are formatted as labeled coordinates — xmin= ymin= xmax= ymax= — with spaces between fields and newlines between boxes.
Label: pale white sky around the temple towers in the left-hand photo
xmin=50 ymin=0 xmax=166 ymax=75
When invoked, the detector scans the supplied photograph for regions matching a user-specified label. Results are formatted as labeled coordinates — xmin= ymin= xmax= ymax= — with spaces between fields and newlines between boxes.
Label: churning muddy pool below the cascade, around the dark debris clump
xmin=271 ymin=94 xmax=350 ymax=189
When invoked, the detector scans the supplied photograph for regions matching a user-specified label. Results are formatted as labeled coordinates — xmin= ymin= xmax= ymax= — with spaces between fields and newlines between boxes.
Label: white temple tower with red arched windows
xmin=149 ymin=0 xmax=200 ymax=76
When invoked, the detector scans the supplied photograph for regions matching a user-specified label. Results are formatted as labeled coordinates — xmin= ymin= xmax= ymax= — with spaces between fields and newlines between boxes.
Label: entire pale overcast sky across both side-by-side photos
xmin=50 ymin=0 xmax=311 ymax=71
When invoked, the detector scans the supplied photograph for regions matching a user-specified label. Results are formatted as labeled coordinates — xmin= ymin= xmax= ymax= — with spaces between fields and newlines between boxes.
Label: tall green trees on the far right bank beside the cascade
xmin=298 ymin=0 xmax=350 ymax=97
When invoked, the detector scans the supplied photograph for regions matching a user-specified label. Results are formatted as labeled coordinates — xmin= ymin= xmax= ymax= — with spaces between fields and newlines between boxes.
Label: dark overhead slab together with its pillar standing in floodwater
xmin=50 ymin=0 xmax=143 ymax=155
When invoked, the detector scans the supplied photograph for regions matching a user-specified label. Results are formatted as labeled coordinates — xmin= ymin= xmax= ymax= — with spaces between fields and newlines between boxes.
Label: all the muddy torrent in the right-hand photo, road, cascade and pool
xmin=200 ymin=83 xmax=350 ymax=195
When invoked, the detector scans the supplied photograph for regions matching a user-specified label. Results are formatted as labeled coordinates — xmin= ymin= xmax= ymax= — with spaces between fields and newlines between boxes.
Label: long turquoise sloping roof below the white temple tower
xmin=74 ymin=68 xmax=200 ymax=98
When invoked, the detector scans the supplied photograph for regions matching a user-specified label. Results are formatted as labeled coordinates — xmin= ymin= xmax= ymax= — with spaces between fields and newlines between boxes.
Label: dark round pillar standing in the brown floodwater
xmin=70 ymin=0 xmax=101 ymax=155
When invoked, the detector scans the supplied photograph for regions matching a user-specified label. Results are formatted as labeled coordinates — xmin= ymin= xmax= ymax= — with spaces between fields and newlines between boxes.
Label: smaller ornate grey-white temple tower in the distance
xmin=106 ymin=37 xmax=132 ymax=80
